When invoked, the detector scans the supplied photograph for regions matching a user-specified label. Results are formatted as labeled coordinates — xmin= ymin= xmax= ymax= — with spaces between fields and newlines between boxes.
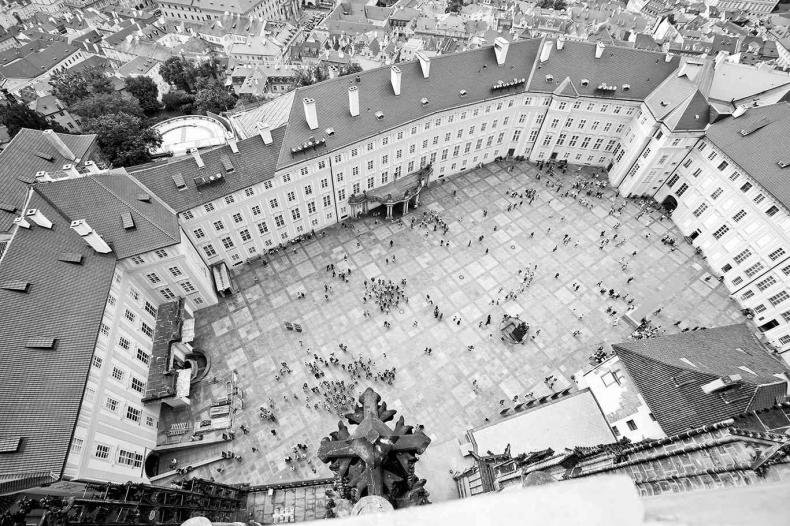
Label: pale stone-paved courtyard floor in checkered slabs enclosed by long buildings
xmin=160 ymin=163 xmax=742 ymax=501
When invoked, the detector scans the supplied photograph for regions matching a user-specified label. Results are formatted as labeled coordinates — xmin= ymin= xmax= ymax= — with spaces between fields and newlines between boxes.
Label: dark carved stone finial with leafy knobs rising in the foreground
xmin=318 ymin=387 xmax=431 ymax=514
